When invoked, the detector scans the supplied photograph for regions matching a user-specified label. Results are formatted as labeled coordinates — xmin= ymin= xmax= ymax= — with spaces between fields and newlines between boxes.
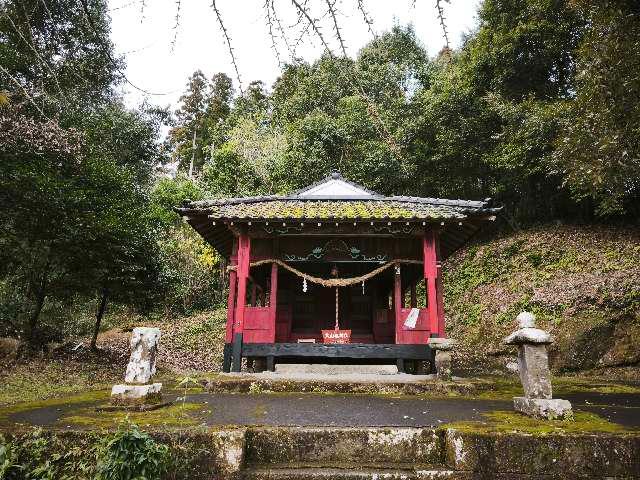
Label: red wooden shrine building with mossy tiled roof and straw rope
xmin=177 ymin=173 xmax=500 ymax=372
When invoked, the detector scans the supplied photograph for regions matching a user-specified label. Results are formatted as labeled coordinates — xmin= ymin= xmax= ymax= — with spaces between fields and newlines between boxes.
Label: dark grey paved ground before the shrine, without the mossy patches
xmin=8 ymin=393 xmax=640 ymax=429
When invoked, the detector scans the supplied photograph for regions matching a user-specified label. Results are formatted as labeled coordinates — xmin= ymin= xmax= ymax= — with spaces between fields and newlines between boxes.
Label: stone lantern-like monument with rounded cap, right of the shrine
xmin=504 ymin=312 xmax=573 ymax=420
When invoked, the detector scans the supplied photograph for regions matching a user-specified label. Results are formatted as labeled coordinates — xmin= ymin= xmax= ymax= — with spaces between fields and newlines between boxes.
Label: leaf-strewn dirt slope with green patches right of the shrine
xmin=443 ymin=226 xmax=640 ymax=378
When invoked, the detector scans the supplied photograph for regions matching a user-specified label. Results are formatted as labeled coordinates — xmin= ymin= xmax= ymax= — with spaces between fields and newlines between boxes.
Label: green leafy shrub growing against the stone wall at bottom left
xmin=96 ymin=422 xmax=171 ymax=480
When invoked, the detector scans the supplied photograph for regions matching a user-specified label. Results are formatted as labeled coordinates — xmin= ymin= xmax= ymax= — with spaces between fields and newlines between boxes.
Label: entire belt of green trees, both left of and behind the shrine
xmin=0 ymin=0 xmax=640 ymax=343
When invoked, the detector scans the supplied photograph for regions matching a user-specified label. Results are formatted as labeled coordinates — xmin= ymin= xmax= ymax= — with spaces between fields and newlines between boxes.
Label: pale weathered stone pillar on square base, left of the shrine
xmin=111 ymin=327 xmax=162 ymax=405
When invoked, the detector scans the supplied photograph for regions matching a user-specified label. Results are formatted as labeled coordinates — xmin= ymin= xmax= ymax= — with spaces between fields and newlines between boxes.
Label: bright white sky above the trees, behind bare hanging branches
xmin=109 ymin=0 xmax=480 ymax=108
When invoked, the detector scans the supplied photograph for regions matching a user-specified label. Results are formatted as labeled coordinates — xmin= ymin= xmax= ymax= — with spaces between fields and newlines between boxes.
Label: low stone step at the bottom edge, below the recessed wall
xmin=242 ymin=466 xmax=462 ymax=480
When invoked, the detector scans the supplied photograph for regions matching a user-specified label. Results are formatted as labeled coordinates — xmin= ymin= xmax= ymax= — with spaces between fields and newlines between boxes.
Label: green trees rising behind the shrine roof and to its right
xmin=174 ymin=0 xmax=640 ymax=219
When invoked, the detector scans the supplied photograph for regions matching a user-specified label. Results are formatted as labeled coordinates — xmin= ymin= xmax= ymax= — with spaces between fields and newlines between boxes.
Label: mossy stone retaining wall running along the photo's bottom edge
xmin=0 ymin=426 xmax=640 ymax=480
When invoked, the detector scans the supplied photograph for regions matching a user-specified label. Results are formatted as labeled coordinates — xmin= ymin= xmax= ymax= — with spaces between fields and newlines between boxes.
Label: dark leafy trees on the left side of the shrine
xmin=0 ymin=0 xmax=217 ymax=346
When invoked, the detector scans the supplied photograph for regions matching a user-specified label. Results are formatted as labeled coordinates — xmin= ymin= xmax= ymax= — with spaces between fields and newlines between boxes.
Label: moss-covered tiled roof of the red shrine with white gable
xmin=176 ymin=173 xmax=501 ymax=258
